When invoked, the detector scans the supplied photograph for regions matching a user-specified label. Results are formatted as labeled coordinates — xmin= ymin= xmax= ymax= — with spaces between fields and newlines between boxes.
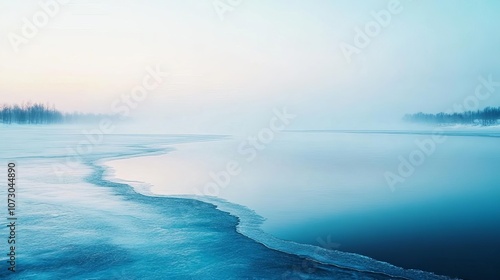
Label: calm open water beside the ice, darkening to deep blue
xmin=111 ymin=131 xmax=500 ymax=279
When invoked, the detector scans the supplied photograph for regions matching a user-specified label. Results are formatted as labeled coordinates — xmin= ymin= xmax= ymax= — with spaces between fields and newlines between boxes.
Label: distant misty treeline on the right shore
xmin=403 ymin=107 xmax=500 ymax=126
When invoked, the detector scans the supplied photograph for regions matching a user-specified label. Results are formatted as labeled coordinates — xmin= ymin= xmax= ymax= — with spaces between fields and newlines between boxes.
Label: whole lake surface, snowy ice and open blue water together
xmin=0 ymin=127 xmax=500 ymax=279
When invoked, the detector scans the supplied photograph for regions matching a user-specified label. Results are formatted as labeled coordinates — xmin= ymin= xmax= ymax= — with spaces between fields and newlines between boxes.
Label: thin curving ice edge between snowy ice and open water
xmin=99 ymin=145 xmax=451 ymax=280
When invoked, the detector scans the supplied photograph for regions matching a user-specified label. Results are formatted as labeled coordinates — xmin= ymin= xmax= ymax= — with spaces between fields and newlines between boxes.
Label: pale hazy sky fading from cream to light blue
xmin=0 ymin=0 xmax=500 ymax=130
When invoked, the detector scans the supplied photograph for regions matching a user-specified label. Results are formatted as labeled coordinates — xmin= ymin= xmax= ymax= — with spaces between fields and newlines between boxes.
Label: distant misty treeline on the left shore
xmin=0 ymin=103 xmax=115 ymax=124
